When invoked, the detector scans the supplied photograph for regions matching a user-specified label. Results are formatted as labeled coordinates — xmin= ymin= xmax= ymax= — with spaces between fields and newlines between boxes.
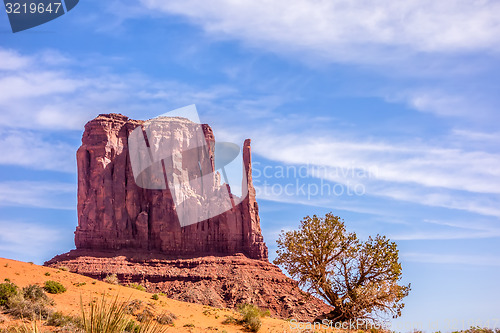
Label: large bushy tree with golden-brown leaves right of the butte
xmin=274 ymin=213 xmax=410 ymax=321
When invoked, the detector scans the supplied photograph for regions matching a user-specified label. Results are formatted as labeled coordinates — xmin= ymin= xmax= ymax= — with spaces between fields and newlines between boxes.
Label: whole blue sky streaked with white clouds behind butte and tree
xmin=0 ymin=0 xmax=500 ymax=331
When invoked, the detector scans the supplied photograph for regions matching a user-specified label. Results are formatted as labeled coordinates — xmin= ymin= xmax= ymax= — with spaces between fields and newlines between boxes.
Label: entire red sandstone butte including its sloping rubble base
xmin=45 ymin=114 xmax=331 ymax=320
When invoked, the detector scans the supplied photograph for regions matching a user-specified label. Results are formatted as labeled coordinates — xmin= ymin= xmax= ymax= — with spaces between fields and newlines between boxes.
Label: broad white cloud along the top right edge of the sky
xmin=141 ymin=0 xmax=500 ymax=62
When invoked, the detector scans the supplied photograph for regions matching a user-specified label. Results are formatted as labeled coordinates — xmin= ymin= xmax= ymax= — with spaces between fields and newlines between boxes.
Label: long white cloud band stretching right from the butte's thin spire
xmin=253 ymin=131 xmax=500 ymax=194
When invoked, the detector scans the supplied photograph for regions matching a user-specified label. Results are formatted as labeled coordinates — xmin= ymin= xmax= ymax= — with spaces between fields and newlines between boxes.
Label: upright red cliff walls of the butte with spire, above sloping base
xmin=75 ymin=114 xmax=268 ymax=260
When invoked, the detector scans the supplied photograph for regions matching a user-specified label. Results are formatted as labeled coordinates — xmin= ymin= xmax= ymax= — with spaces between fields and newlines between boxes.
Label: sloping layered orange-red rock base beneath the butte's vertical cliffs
xmin=46 ymin=250 xmax=333 ymax=321
